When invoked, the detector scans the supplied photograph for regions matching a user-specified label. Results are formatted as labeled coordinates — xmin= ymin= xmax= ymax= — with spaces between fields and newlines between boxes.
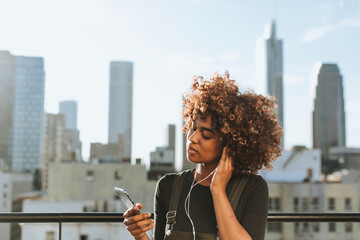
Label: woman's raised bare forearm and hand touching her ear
xmin=210 ymin=148 xmax=251 ymax=240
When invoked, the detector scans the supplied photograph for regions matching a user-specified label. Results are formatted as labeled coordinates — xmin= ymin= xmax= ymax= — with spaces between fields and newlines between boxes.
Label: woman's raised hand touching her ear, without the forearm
xmin=210 ymin=147 xmax=234 ymax=192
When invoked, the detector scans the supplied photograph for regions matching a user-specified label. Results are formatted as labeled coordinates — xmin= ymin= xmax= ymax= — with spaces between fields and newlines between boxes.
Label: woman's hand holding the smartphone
xmin=123 ymin=203 xmax=154 ymax=239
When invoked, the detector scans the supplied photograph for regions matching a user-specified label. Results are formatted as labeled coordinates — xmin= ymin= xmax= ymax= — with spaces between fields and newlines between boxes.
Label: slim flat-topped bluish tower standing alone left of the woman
xmin=108 ymin=61 xmax=133 ymax=161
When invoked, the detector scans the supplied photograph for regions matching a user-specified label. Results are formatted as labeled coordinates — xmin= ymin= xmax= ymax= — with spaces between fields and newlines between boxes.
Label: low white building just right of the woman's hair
xmin=260 ymin=146 xmax=321 ymax=182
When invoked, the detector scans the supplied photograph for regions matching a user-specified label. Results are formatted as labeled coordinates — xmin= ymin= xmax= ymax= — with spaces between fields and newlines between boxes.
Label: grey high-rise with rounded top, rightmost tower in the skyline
xmin=311 ymin=62 xmax=346 ymax=160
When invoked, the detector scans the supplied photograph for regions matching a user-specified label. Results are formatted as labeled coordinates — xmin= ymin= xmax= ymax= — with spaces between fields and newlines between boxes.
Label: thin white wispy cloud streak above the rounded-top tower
xmin=300 ymin=18 xmax=360 ymax=43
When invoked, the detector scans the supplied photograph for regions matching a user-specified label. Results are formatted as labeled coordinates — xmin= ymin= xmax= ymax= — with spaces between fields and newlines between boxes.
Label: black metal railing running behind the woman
xmin=0 ymin=212 xmax=360 ymax=240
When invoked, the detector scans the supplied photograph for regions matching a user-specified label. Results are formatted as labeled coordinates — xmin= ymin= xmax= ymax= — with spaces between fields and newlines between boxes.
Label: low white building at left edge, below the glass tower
xmin=0 ymin=171 xmax=33 ymax=240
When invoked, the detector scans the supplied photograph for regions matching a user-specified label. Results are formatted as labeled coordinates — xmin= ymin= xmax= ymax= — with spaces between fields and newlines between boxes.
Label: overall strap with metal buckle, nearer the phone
xmin=165 ymin=170 xmax=189 ymax=236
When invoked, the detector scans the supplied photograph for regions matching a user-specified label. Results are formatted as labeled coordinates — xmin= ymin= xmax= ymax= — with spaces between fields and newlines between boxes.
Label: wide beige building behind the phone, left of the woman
xmin=48 ymin=163 xmax=156 ymax=211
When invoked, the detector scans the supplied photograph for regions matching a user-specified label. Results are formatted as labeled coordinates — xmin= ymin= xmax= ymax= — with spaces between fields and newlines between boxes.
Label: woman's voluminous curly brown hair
xmin=183 ymin=72 xmax=283 ymax=174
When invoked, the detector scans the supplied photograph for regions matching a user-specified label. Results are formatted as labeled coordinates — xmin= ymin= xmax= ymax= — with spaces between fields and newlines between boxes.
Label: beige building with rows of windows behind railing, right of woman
xmin=266 ymin=182 xmax=360 ymax=240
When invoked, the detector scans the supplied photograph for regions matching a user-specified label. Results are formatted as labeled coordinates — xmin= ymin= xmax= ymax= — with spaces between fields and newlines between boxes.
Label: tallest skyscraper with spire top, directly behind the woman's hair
xmin=256 ymin=21 xmax=284 ymax=147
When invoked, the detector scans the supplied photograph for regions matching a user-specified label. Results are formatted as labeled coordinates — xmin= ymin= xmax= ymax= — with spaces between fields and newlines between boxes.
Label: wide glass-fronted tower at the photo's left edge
xmin=0 ymin=51 xmax=45 ymax=172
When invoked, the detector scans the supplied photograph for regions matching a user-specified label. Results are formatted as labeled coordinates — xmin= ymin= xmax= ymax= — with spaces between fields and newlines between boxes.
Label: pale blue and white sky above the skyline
xmin=0 ymin=0 xmax=360 ymax=167
